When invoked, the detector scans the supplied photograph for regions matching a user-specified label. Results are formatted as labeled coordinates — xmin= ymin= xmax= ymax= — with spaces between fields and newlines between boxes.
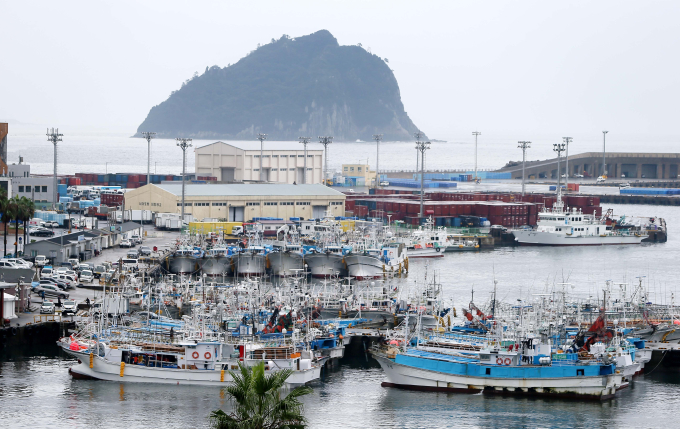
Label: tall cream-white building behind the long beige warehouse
xmin=194 ymin=141 xmax=323 ymax=184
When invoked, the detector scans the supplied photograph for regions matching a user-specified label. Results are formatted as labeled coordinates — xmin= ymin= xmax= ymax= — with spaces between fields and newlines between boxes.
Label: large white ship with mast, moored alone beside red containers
xmin=512 ymin=190 xmax=647 ymax=246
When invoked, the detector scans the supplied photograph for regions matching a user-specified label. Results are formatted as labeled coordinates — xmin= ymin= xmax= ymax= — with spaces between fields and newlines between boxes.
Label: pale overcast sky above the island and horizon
xmin=0 ymin=0 xmax=680 ymax=139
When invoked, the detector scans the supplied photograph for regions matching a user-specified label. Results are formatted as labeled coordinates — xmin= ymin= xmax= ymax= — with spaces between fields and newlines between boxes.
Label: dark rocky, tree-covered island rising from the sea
xmin=137 ymin=30 xmax=424 ymax=141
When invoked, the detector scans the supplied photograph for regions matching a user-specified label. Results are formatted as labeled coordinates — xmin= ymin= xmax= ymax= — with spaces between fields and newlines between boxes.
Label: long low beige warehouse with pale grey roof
xmin=125 ymin=183 xmax=345 ymax=222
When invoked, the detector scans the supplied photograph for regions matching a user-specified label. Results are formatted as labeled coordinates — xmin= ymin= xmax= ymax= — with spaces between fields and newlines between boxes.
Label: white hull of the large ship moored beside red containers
xmin=512 ymin=230 xmax=647 ymax=246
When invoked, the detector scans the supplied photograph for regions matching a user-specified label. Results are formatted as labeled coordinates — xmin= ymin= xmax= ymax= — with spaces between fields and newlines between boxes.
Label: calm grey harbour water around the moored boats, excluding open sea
xmin=0 ymin=202 xmax=680 ymax=428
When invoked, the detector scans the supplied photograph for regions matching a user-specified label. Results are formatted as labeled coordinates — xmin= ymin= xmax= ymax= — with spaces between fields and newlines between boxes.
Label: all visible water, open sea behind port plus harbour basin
xmin=0 ymin=130 xmax=680 ymax=429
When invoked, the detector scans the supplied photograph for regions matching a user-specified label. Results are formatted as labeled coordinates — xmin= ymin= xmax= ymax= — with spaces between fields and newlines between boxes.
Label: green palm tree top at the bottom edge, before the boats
xmin=210 ymin=363 xmax=312 ymax=429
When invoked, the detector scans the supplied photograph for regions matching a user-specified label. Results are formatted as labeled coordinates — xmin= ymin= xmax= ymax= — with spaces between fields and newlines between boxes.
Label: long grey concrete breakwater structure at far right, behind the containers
xmin=497 ymin=152 xmax=680 ymax=180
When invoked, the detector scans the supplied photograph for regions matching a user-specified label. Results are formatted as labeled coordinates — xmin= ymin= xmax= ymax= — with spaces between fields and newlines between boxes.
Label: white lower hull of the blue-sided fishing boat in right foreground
xmin=373 ymin=353 xmax=622 ymax=400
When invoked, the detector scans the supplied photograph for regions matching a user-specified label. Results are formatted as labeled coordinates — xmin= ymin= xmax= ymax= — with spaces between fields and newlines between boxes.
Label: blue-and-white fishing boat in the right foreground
xmin=371 ymin=339 xmax=623 ymax=400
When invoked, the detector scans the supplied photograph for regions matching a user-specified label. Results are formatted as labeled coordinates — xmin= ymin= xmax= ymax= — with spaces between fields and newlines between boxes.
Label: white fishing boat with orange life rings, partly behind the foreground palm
xmin=58 ymin=337 xmax=321 ymax=386
